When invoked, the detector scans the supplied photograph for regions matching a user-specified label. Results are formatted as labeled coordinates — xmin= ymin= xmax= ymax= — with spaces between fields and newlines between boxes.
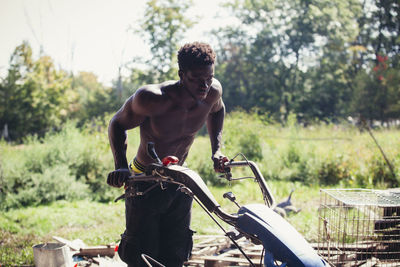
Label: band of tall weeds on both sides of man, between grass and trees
xmin=0 ymin=111 xmax=400 ymax=210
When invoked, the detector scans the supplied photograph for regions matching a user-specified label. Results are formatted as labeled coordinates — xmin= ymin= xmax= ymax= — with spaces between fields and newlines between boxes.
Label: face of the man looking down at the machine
xmin=179 ymin=64 xmax=214 ymax=100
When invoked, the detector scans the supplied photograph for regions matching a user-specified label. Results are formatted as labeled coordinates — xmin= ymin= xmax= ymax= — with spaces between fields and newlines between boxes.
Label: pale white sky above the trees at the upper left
xmin=0 ymin=0 xmax=238 ymax=85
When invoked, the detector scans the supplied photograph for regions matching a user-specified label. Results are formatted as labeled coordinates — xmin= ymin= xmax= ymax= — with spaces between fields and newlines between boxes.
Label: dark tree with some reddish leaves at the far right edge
xmin=351 ymin=0 xmax=400 ymax=122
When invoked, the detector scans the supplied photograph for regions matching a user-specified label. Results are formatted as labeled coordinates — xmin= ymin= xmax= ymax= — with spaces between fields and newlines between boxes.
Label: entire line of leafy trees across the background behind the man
xmin=0 ymin=0 xmax=400 ymax=142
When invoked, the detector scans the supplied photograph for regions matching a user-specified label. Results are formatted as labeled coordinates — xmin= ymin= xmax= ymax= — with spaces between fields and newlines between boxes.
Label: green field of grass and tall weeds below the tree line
xmin=0 ymin=112 xmax=400 ymax=266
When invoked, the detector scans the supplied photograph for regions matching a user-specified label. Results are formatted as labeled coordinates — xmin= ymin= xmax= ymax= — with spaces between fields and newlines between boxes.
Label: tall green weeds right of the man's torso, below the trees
xmin=187 ymin=111 xmax=400 ymax=187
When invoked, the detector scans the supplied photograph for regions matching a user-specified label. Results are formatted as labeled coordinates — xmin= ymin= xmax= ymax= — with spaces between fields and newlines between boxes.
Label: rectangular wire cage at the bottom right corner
xmin=318 ymin=189 xmax=400 ymax=267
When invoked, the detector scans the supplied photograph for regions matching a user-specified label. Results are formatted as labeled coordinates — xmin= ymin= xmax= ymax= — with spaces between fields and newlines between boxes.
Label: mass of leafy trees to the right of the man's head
xmin=214 ymin=0 xmax=400 ymax=122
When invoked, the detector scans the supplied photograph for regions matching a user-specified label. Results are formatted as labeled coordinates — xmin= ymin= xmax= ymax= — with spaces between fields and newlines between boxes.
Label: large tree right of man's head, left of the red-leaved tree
xmin=218 ymin=0 xmax=360 ymax=121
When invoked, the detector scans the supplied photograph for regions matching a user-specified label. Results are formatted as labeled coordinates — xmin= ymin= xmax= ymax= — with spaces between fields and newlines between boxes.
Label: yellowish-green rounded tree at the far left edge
xmin=0 ymin=42 xmax=71 ymax=140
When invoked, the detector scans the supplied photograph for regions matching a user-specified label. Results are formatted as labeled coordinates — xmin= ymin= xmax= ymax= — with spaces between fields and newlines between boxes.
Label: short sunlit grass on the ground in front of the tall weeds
xmin=0 ymin=181 xmax=319 ymax=267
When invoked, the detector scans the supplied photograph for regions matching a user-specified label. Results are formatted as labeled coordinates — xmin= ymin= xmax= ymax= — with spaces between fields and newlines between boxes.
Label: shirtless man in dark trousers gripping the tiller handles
xmin=107 ymin=42 xmax=228 ymax=267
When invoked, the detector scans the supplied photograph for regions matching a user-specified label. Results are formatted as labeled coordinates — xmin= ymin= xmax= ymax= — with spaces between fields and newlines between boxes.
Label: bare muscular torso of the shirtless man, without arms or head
xmin=133 ymin=79 xmax=221 ymax=165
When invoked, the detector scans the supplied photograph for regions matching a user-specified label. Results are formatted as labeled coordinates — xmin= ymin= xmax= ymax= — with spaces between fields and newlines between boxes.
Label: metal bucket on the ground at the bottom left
xmin=33 ymin=243 xmax=73 ymax=267
